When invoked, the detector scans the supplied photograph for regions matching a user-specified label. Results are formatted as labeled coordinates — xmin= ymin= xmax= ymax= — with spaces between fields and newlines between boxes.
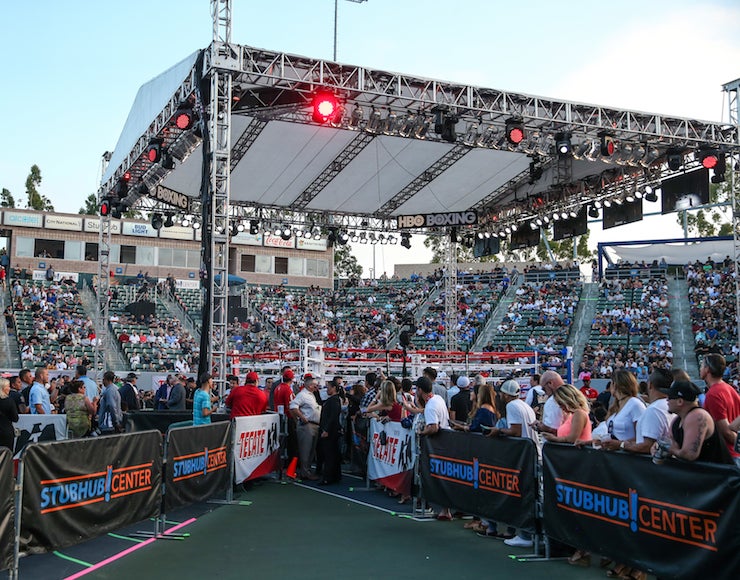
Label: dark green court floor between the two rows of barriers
xmin=10 ymin=478 xmax=624 ymax=580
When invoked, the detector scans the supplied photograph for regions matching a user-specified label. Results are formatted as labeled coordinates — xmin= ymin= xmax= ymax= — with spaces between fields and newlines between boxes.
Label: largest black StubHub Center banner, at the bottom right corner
xmin=543 ymin=443 xmax=740 ymax=580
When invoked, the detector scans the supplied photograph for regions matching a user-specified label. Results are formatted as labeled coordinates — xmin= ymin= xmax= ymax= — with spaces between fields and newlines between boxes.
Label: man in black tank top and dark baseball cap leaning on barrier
xmin=661 ymin=381 xmax=734 ymax=464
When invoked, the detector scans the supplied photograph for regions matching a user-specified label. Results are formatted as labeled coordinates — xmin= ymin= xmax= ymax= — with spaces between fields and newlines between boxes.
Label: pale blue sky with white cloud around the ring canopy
xmin=0 ymin=0 xmax=740 ymax=273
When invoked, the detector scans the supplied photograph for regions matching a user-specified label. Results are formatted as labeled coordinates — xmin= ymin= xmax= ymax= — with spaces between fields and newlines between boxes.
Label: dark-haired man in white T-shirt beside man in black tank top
xmin=601 ymin=369 xmax=675 ymax=454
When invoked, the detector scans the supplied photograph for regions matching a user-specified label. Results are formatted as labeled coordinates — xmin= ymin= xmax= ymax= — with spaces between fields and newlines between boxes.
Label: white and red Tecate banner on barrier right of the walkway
xmin=367 ymin=419 xmax=416 ymax=495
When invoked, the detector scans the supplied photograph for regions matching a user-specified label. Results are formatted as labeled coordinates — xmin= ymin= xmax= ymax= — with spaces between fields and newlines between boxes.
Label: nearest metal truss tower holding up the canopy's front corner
xmin=207 ymin=0 xmax=241 ymax=401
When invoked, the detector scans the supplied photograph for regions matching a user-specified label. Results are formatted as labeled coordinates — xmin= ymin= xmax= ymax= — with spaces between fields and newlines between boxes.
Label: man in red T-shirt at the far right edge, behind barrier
xmin=699 ymin=354 xmax=740 ymax=466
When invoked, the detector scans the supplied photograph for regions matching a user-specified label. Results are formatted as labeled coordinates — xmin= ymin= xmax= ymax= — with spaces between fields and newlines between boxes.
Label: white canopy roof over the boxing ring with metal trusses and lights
xmin=98 ymin=0 xmax=740 ymax=389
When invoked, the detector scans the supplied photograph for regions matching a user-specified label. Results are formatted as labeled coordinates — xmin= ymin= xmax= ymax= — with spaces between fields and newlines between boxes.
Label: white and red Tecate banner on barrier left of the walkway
xmin=234 ymin=413 xmax=280 ymax=483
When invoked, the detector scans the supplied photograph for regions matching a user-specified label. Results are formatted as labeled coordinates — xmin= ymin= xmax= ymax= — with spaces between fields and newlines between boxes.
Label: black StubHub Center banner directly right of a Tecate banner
xmin=419 ymin=430 xmax=538 ymax=529
